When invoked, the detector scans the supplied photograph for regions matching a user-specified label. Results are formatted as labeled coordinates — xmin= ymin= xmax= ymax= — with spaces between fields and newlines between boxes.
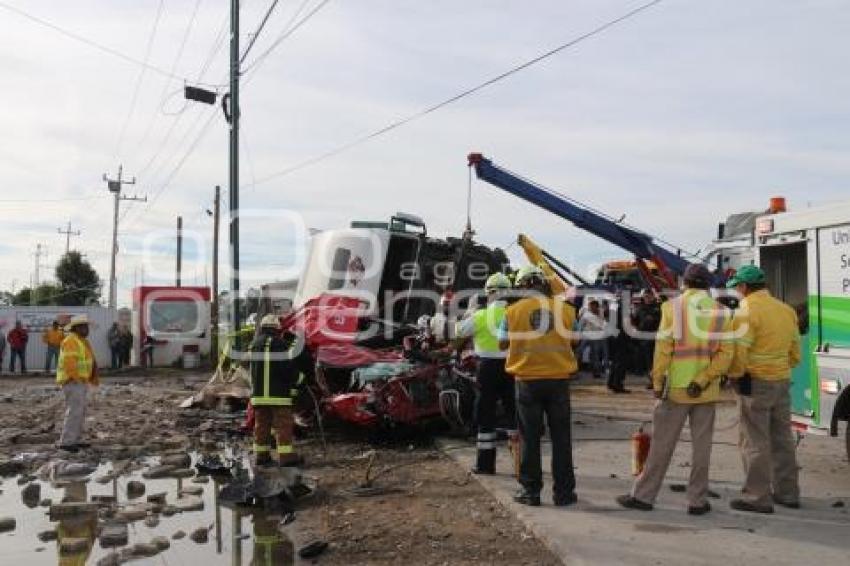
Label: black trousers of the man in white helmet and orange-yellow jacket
xmin=516 ymin=382 xmax=576 ymax=496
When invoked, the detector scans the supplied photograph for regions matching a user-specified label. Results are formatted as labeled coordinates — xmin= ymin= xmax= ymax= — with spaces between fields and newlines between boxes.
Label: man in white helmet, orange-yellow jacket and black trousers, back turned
xmin=498 ymin=265 xmax=578 ymax=506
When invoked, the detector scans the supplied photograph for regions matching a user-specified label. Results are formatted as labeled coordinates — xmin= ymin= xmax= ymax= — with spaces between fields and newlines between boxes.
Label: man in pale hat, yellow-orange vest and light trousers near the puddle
xmin=56 ymin=314 xmax=99 ymax=452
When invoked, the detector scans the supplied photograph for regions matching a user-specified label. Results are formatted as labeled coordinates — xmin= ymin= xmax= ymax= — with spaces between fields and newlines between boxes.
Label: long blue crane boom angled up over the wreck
xmin=469 ymin=153 xmax=704 ymax=286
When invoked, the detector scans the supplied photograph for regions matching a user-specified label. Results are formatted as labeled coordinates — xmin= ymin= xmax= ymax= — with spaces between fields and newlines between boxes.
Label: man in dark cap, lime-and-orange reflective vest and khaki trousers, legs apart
xmin=617 ymin=264 xmax=734 ymax=515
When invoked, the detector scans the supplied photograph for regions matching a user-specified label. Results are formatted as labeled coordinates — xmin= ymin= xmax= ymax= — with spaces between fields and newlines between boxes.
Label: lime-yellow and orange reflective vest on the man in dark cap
xmin=668 ymin=294 xmax=726 ymax=389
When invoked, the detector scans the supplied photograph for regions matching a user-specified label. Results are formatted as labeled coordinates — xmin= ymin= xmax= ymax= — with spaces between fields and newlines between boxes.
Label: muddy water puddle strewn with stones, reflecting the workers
xmin=0 ymin=453 xmax=299 ymax=566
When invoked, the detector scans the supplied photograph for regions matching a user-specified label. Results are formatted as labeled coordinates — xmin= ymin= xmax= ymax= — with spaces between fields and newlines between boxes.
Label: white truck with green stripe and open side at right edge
xmin=754 ymin=202 xmax=850 ymax=457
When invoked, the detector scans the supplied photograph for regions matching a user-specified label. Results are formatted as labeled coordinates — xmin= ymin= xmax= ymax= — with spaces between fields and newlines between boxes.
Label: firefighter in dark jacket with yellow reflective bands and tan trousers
xmin=249 ymin=314 xmax=303 ymax=466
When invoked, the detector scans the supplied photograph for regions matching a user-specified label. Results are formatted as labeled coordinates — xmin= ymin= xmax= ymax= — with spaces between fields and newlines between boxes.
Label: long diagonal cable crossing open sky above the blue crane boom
xmin=254 ymin=0 xmax=663 ymax=189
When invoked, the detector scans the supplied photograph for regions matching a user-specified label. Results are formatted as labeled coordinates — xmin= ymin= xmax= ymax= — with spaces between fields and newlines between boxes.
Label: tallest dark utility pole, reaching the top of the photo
xmin=230 ymin=0 xmax=241 ymax=351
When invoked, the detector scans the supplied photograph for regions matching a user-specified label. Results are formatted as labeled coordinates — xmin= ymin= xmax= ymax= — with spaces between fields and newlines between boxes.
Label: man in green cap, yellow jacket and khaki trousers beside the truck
xmin=727 ymin=265 xmax=800 ymax=513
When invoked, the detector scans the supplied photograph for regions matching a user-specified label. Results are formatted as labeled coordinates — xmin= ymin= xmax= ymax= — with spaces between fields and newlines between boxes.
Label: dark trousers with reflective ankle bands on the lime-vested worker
xmin=475 ymin=358 xmax=516 ymax=473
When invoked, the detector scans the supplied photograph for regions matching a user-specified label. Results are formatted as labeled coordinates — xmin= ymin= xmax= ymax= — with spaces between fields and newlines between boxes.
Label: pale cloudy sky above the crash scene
xmin=0 ymin=0 xmax=850 ymax=304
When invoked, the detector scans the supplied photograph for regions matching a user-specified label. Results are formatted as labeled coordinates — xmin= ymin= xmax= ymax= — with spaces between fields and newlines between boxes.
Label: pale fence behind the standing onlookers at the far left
xmin=0 ymin=307 xmax=118 ymax=373
